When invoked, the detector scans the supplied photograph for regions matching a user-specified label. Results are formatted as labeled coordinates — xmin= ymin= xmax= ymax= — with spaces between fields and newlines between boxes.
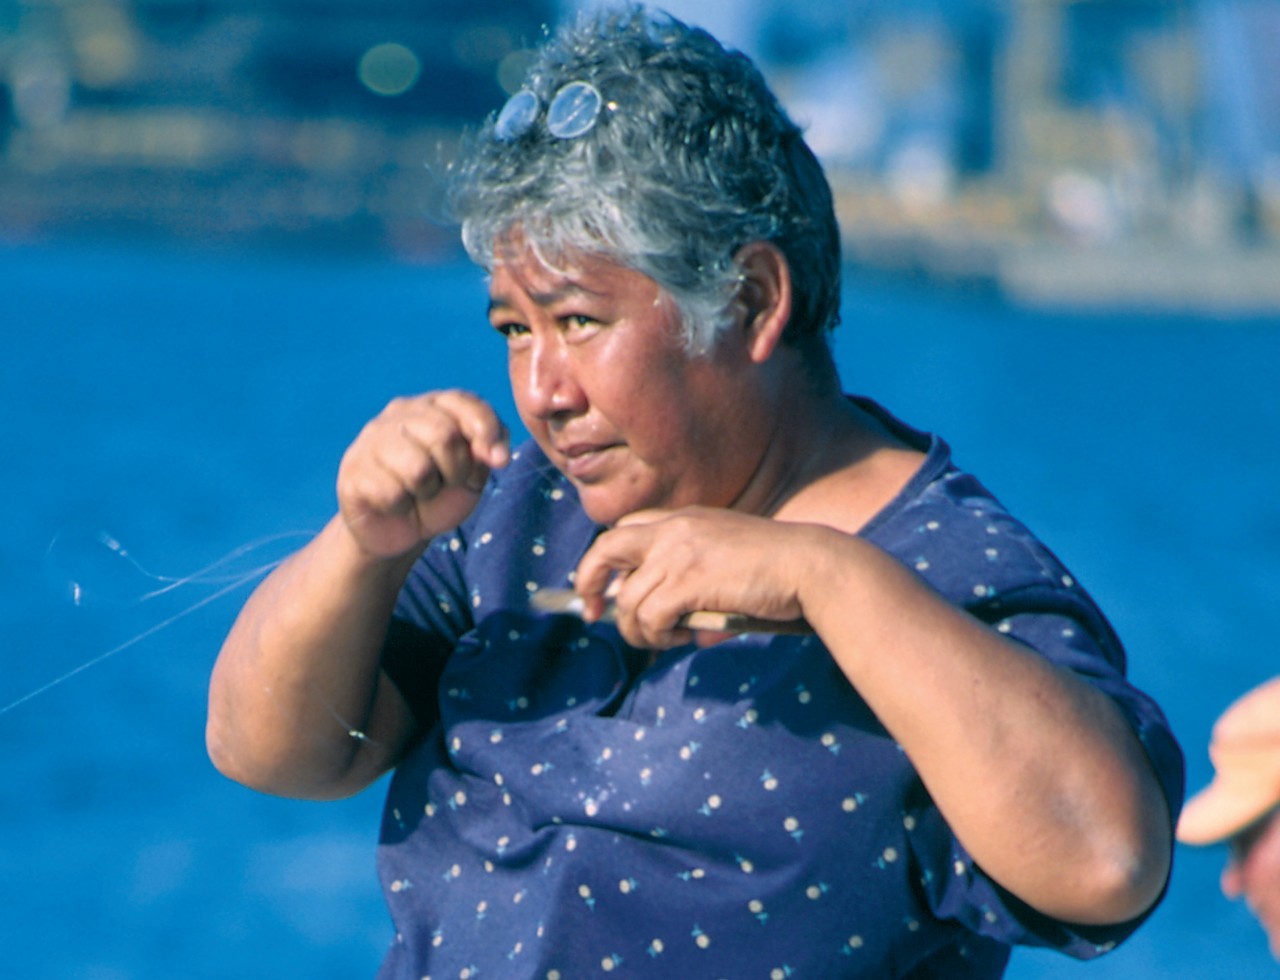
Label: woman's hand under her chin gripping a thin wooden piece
xmin=575 ymin=507 xmax=819 ymax=650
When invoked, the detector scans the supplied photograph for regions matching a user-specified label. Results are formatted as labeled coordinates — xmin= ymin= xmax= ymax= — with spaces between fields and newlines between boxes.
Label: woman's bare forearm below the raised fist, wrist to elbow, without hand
xmin=206 ymin=518 xmax=412 ymax=797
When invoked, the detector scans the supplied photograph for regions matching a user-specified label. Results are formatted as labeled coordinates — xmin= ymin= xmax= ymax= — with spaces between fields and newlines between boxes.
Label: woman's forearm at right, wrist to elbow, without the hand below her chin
xmin=801 ymin=535 xmax=1170 ymax=922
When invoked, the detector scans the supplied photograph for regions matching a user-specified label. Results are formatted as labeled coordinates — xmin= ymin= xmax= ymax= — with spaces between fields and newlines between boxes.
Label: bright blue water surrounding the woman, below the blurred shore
xmin=0 ymin=244 xmax=1280 ymax=980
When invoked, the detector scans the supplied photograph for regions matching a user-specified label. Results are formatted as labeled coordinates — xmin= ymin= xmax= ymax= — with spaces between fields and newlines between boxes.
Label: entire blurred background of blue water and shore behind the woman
xmin=0 ymin=0 xmax=1280 ymax=980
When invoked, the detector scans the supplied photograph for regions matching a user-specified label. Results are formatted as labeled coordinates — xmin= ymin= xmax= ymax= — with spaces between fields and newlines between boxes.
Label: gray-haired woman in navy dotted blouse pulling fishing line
xmin=209 ymin=3 xmax=1181 ymax=977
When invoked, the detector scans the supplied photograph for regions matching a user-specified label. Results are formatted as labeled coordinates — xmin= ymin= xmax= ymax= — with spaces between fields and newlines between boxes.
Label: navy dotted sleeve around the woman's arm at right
xmin=872 ymin=458 xmax=1185 ymax=960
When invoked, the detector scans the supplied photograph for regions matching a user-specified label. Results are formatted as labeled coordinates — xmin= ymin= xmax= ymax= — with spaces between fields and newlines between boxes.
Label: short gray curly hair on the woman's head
xmin=449 ymin=4 xmax=840 ymax=352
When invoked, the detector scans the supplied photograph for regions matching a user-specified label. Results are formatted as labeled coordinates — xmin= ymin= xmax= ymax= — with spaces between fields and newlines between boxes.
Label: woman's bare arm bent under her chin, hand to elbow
xmin=577 ymin=510 xmax=1171 ymax=924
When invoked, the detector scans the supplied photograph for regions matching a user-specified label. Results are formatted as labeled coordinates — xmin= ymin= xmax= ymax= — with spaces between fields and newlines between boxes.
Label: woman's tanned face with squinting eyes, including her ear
xmin=489 ymin=248 xmax=769 ymax=525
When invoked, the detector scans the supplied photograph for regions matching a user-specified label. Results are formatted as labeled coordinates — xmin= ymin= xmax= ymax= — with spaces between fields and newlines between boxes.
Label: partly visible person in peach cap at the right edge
xmin=1178 ymin=677 xmax=1280 ymax=960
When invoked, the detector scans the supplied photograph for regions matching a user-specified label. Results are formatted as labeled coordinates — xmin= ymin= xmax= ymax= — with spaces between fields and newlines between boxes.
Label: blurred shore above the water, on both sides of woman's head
xmin=0 ymin=0 xmax=1280 ymax=311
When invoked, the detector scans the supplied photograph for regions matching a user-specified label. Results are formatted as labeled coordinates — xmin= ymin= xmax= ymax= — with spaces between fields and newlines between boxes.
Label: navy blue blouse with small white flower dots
xmin=379 ymin=402 xmax=1183 ymax=980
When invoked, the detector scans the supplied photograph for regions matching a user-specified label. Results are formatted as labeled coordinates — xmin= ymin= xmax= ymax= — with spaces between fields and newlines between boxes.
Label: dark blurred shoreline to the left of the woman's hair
xmin=0 ymin=0 xmax=554 ymax=255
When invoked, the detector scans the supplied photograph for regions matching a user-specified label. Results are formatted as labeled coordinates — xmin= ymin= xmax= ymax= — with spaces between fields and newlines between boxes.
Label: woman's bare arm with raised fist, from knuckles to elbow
xmin=206 ymin=391 xmax=508 ymax=798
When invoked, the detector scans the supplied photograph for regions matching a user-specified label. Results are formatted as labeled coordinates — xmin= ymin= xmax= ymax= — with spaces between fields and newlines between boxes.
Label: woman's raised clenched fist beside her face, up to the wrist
xmin=338 ymin=390 xmax=511 ymax=558
